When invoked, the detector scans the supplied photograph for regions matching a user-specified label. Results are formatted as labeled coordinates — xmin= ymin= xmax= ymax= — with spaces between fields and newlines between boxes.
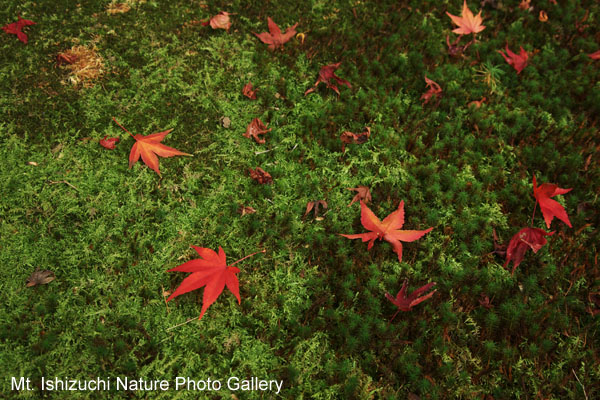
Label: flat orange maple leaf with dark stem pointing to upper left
xmin=113 ymin=117 xmax=191 ymax=176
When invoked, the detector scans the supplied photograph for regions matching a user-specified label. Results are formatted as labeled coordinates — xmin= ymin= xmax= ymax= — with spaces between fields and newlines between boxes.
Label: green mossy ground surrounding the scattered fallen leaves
xmin=0 ymin=0 xmax=600 ymax=399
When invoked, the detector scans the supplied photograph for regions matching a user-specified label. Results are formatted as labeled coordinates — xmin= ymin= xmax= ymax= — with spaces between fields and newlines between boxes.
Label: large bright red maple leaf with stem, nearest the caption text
xmin=167 ymin=246 xmax=266 ymax=319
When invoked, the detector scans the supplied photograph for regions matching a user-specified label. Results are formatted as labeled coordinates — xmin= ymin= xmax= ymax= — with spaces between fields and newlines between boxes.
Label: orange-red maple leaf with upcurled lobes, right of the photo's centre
xmin=340 ymin=200 xmax=433 ymax=262
